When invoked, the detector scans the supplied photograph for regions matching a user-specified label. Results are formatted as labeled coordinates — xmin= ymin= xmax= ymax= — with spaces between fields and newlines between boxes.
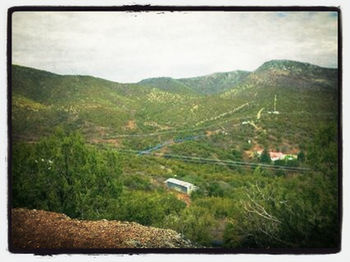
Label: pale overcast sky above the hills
xmin=12 ymin=12 xmax=338 ymax=82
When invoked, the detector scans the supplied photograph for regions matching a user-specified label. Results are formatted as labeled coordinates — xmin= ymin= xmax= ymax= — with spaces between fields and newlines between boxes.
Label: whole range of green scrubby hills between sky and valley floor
xmin=12 ymin=60 xmax=338 ymax=154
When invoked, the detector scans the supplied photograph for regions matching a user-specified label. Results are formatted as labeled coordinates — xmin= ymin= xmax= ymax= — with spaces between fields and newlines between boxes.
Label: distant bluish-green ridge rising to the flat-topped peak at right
xmin=139 ymin=60 xmax=338 ymax=95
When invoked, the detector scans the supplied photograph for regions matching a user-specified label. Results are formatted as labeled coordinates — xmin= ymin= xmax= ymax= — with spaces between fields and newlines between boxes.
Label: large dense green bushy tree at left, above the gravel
xmin=12 ymin=129 xmax=122 ymax=219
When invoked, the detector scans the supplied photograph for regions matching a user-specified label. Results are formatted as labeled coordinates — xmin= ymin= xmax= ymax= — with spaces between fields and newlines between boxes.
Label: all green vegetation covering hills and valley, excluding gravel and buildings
xmin=11 ymin=60 xmax=340 ymax=248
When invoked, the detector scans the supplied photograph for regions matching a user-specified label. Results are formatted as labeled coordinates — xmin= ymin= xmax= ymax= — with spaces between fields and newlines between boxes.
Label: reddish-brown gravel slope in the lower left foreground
xmin=11 ymin=208 xmax=194 ymax=249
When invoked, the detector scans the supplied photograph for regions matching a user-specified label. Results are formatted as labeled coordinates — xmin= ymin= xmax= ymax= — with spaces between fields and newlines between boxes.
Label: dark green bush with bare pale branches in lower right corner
xmin=224 ymin=173 xmax=339 ymax=248
